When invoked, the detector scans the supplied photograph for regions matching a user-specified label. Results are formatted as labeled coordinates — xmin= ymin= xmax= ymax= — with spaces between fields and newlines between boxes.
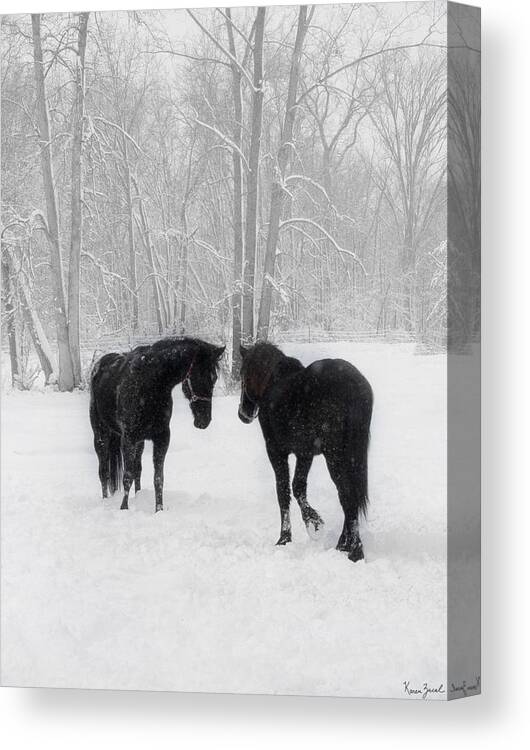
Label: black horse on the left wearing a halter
xmin=90 ymin=338 xmax=225 ymax=511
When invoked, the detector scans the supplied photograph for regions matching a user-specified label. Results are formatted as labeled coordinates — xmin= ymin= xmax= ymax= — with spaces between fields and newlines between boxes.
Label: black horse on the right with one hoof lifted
xmin=239 ymin=343 xmax=373 ymax=562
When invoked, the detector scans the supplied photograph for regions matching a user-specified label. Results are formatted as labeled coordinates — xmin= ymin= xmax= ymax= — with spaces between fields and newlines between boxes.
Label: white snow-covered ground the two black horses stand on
xmin=1 ymin=343 xmax=446 ymax=698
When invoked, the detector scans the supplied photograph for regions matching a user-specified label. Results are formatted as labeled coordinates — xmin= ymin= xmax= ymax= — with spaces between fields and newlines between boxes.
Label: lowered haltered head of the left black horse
xmin=182 ymin=344 xmax=225 ymax=430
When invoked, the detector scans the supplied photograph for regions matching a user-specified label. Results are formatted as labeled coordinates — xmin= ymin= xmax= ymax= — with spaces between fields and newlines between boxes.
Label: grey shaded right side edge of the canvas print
xmin=447 ymin=2 xmax=481 ymax=700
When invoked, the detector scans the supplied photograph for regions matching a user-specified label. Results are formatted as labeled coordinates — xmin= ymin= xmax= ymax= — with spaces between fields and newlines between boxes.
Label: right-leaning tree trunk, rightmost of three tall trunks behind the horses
xmin=257 ymin=5 xmax=308 ymax=340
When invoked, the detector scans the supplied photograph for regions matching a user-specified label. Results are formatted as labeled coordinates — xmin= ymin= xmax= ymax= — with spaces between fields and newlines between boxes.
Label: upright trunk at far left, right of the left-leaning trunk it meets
xmin=68 ymin=13 xmax=89 ymax=386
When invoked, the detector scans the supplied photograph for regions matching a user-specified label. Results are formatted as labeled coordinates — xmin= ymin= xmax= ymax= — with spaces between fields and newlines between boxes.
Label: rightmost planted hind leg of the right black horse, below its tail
xmin=325 ymin=453 xmax=364 ymax=562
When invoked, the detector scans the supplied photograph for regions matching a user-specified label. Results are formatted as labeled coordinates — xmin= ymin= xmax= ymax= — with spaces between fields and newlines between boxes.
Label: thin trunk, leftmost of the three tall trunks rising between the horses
xmin=226 ymin=8 xmax=243 ymax=379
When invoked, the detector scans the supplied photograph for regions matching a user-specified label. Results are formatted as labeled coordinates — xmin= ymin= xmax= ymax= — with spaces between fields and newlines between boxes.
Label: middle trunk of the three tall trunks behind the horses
xmin=242 ymin=7 xmax=266 ymax=344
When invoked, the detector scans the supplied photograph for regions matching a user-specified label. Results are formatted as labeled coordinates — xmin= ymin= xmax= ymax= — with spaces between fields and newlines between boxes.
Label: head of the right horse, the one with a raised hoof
xmin=238 ymin=343 xmax=284 ymax=424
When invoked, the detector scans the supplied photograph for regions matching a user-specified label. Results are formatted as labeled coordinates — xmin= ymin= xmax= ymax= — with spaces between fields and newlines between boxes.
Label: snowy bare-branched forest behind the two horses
xmin=0 ymin=2 xmax=480 ymax=390
